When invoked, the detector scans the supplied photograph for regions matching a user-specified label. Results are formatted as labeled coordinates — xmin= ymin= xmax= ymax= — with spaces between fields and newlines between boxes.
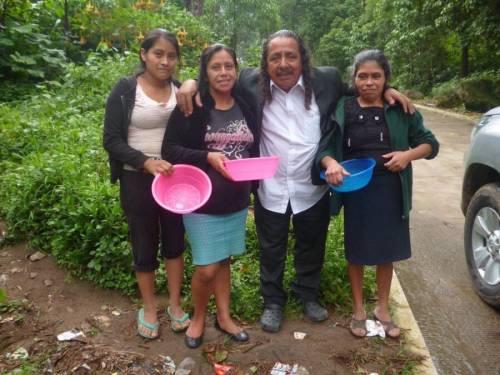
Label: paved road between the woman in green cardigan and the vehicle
xmin=396 ymin=106 xmax=500 ymax=375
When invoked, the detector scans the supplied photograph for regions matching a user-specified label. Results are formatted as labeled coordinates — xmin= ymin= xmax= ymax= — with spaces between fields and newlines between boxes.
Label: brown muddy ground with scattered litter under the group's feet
xmin=0 ymin=244 xmax=426 ymax=375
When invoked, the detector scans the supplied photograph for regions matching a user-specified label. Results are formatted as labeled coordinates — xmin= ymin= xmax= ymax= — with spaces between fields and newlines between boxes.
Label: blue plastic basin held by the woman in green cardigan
xmin=319 ymin=158 xmax=376 ymax=193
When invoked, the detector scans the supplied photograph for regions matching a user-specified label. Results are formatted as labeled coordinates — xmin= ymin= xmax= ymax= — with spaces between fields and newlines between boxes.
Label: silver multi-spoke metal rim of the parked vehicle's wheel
xmin=472 ymin=207 xmax=500 ymax=285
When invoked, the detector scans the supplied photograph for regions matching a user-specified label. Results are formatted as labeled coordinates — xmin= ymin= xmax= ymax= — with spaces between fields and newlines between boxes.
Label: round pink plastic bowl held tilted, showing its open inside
xmin=151 ymin=164 xmax=212 ymax=214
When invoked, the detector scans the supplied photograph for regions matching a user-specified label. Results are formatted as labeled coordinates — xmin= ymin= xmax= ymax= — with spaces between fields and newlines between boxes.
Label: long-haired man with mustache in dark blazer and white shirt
xmin=239 ymin=30 xmax=347 ymax=332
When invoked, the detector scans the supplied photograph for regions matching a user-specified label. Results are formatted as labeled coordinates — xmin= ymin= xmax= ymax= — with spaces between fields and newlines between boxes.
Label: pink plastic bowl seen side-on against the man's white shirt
xmin=224 ymin=156 xmax=280 ymax=181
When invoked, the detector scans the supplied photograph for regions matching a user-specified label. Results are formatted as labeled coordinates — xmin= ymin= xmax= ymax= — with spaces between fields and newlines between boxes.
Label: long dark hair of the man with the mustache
xmin=260 ymin=30 xmax=313 ymax=109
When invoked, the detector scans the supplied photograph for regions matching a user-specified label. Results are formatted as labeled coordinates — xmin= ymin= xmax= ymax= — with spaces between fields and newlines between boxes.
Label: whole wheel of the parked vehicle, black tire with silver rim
xmin=464 ymin=183 xmax=500 ymax=309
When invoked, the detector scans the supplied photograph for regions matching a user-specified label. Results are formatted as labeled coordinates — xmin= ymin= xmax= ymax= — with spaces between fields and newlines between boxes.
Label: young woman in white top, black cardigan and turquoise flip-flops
xmin=104 ymin=29 xmax=190 ymax=339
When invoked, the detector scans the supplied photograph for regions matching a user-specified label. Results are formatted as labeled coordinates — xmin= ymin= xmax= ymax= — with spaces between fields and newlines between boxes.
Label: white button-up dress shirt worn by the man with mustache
xmin=258 ymin=76 xmax=328 ymax=214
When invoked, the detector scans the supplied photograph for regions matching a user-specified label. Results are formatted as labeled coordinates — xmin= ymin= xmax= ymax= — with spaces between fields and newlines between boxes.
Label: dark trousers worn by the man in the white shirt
xmin=255 ymin=192 xmax=330 ymax=307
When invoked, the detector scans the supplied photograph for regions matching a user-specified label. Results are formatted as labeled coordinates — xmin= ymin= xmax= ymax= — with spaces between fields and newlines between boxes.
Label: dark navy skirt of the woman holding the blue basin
xmin=342 ymin=173 xmax=411 ymax=265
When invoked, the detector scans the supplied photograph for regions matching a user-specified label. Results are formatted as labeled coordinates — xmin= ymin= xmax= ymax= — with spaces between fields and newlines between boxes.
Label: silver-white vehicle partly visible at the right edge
xmin=462 ymin=107 xmax=500 ymax=308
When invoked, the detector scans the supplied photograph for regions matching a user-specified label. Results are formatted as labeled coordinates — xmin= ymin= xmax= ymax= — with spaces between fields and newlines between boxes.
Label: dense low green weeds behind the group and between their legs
xmin=0 ymin=55 xmax=374 ymax=320
